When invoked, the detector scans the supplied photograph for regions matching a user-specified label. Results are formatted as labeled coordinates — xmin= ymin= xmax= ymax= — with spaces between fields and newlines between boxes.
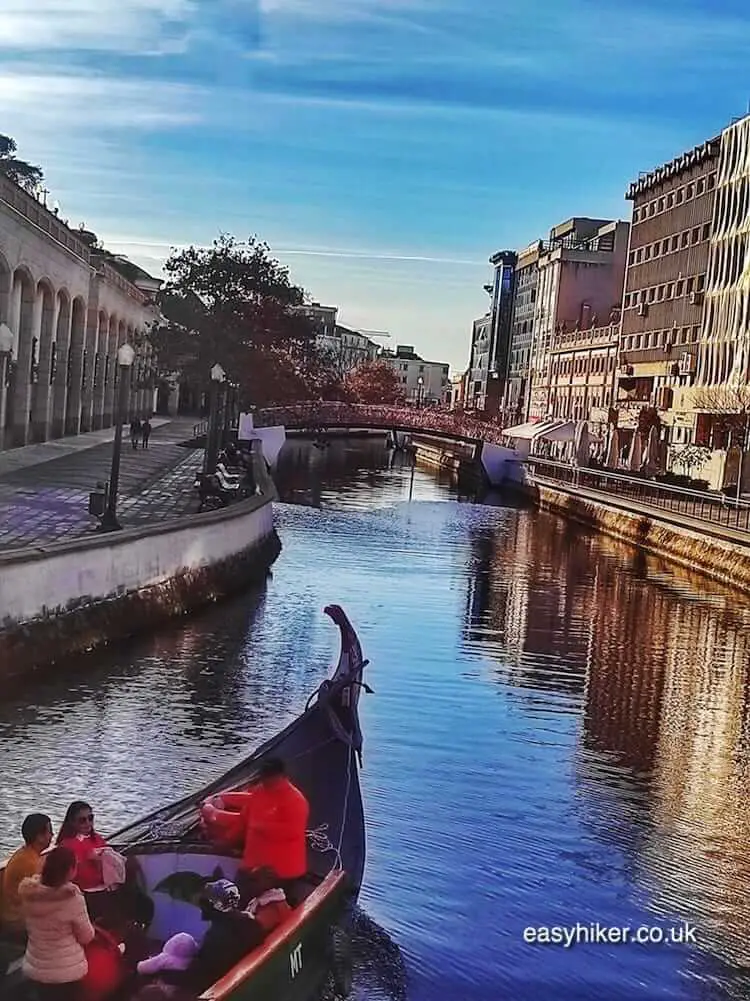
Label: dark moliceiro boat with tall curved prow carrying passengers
xmin=0 ymin=605 xmax=370 ymax=1001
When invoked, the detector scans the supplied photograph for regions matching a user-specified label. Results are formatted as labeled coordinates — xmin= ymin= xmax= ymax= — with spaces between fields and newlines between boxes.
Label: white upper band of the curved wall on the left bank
xmin=0 ymin=497 xmax=273 ymax=623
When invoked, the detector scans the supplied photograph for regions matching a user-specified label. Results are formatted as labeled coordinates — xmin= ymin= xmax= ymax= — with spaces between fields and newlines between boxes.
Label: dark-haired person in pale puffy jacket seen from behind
xmin=18 ymin=847 xmax=95 ymax=1001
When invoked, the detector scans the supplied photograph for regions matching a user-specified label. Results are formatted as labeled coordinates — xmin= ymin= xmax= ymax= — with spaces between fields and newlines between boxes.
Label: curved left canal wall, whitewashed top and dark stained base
xmin=0 ymin=454 xmax=281 ymax=680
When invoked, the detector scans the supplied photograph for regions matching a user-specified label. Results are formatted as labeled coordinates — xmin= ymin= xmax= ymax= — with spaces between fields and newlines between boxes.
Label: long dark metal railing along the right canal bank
xmin=527 ymin=455 xmax=750 ymax=533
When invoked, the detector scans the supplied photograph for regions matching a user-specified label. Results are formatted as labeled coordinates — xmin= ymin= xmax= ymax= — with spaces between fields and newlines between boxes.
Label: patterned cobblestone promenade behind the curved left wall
xmin=0 ymin=418 xmax=203 ymax=551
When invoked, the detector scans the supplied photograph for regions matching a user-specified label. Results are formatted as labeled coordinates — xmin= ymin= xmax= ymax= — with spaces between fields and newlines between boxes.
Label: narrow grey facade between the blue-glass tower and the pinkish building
xmin=502 ymin=240 xmax=542 ymax=424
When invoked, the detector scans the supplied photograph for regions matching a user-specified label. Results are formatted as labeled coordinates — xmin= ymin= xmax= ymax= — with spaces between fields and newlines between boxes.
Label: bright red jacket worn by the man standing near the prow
xmin=210 ymin=778 xmax=309 ymax=879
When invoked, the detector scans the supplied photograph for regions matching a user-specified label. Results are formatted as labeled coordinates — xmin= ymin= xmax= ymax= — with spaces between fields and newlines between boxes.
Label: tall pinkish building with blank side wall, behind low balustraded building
xmin=528 ymin=218 xmax=630 ymax=418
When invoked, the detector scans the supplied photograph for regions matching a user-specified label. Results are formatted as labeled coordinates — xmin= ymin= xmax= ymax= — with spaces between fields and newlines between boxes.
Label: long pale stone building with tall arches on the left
xmin=0 ymin=176 xmax=158 ymax=447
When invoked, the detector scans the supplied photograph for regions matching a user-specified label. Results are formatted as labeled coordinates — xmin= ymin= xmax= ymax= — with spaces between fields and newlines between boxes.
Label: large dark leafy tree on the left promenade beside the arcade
xmin=151 ymin=235 xmax=340 ymax=406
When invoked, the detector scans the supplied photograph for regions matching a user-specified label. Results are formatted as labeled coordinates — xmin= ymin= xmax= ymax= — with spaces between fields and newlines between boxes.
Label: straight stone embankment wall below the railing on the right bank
xmin=529 ymin=481 xmax=750 ymax=593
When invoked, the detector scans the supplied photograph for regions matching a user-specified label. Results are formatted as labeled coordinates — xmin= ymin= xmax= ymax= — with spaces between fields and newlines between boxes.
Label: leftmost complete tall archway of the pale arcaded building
xmin=5 ymin=266 xmax=36 ymax=446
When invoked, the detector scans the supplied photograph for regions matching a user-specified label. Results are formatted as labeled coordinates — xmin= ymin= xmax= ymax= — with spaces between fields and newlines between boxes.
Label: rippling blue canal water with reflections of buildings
xmin=0 ymin=441 xmax=750 ymax=1001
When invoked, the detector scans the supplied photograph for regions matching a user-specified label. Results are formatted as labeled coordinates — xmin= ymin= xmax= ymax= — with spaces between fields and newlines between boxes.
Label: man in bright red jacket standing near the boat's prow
xmin=201 ymin=758 xmax=309 ymax=900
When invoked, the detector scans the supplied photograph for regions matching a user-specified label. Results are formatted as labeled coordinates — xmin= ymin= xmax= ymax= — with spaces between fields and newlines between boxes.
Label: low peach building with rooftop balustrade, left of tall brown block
xmin=550 ymin=315 xmax=620 ymax=429
